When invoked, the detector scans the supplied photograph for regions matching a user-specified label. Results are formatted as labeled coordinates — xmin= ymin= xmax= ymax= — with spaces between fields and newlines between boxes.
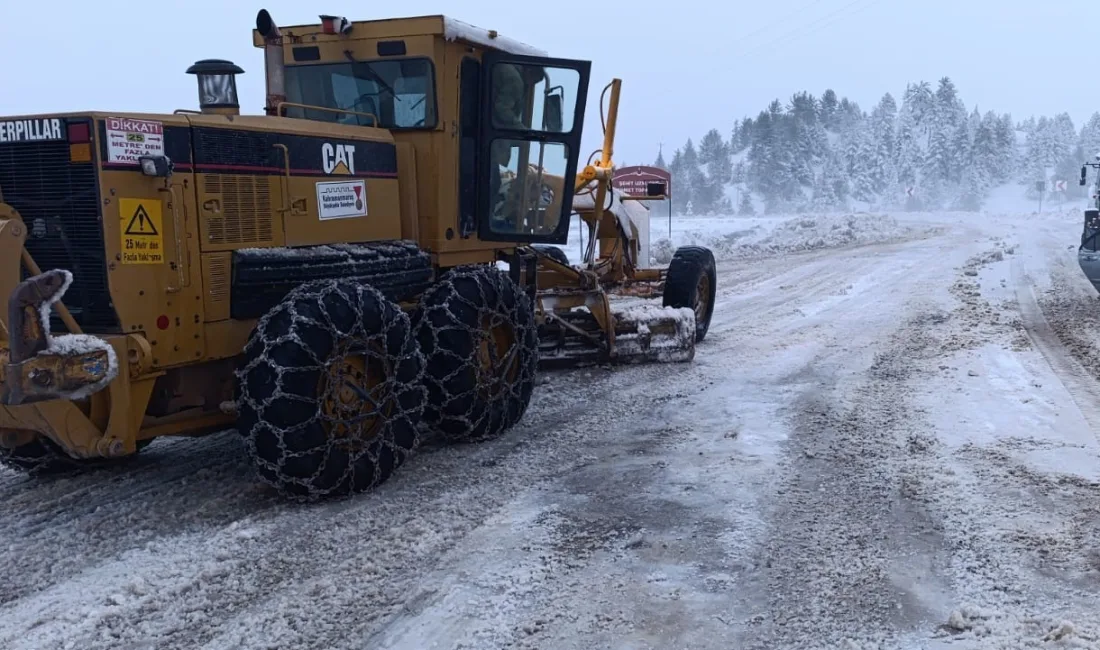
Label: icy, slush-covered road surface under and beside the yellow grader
xmin=0 ymin=212 xmax=1100 ymax=650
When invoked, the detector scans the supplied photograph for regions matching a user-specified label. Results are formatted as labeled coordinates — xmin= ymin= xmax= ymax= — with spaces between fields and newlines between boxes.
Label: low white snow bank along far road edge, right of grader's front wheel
xmin=652 ymin=213 xmax=917 ymax=264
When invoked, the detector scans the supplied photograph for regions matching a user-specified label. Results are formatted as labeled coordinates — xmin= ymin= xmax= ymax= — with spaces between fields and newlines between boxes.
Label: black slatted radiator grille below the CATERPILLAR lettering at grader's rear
xmin=0 ymin=131 xmax=119 ymax=333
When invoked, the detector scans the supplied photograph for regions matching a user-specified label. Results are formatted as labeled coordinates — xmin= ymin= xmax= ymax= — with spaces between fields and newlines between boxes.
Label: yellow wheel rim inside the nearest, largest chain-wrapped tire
xmin=318 ymin=346 xmax=393 ymax=452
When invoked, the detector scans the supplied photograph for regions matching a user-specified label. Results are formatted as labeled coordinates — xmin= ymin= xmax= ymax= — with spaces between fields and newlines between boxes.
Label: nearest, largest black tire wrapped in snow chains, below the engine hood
xmin=237 ymin=279 xmax=426 ymax=500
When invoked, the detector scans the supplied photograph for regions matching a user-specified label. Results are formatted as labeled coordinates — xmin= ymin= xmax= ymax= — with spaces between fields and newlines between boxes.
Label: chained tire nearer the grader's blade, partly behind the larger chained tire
xmin=415 ymin=265 xmax=539 ymax=442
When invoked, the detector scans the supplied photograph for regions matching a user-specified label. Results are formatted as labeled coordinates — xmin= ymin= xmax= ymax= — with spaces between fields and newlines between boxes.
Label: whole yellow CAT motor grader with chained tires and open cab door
xmin=0 ymin=11 xmax=715 ymax=498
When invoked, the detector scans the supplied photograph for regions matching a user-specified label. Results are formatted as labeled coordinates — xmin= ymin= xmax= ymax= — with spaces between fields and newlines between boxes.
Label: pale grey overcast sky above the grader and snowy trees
xmin=0 ymin=0 xmax=1100 ymax=164
